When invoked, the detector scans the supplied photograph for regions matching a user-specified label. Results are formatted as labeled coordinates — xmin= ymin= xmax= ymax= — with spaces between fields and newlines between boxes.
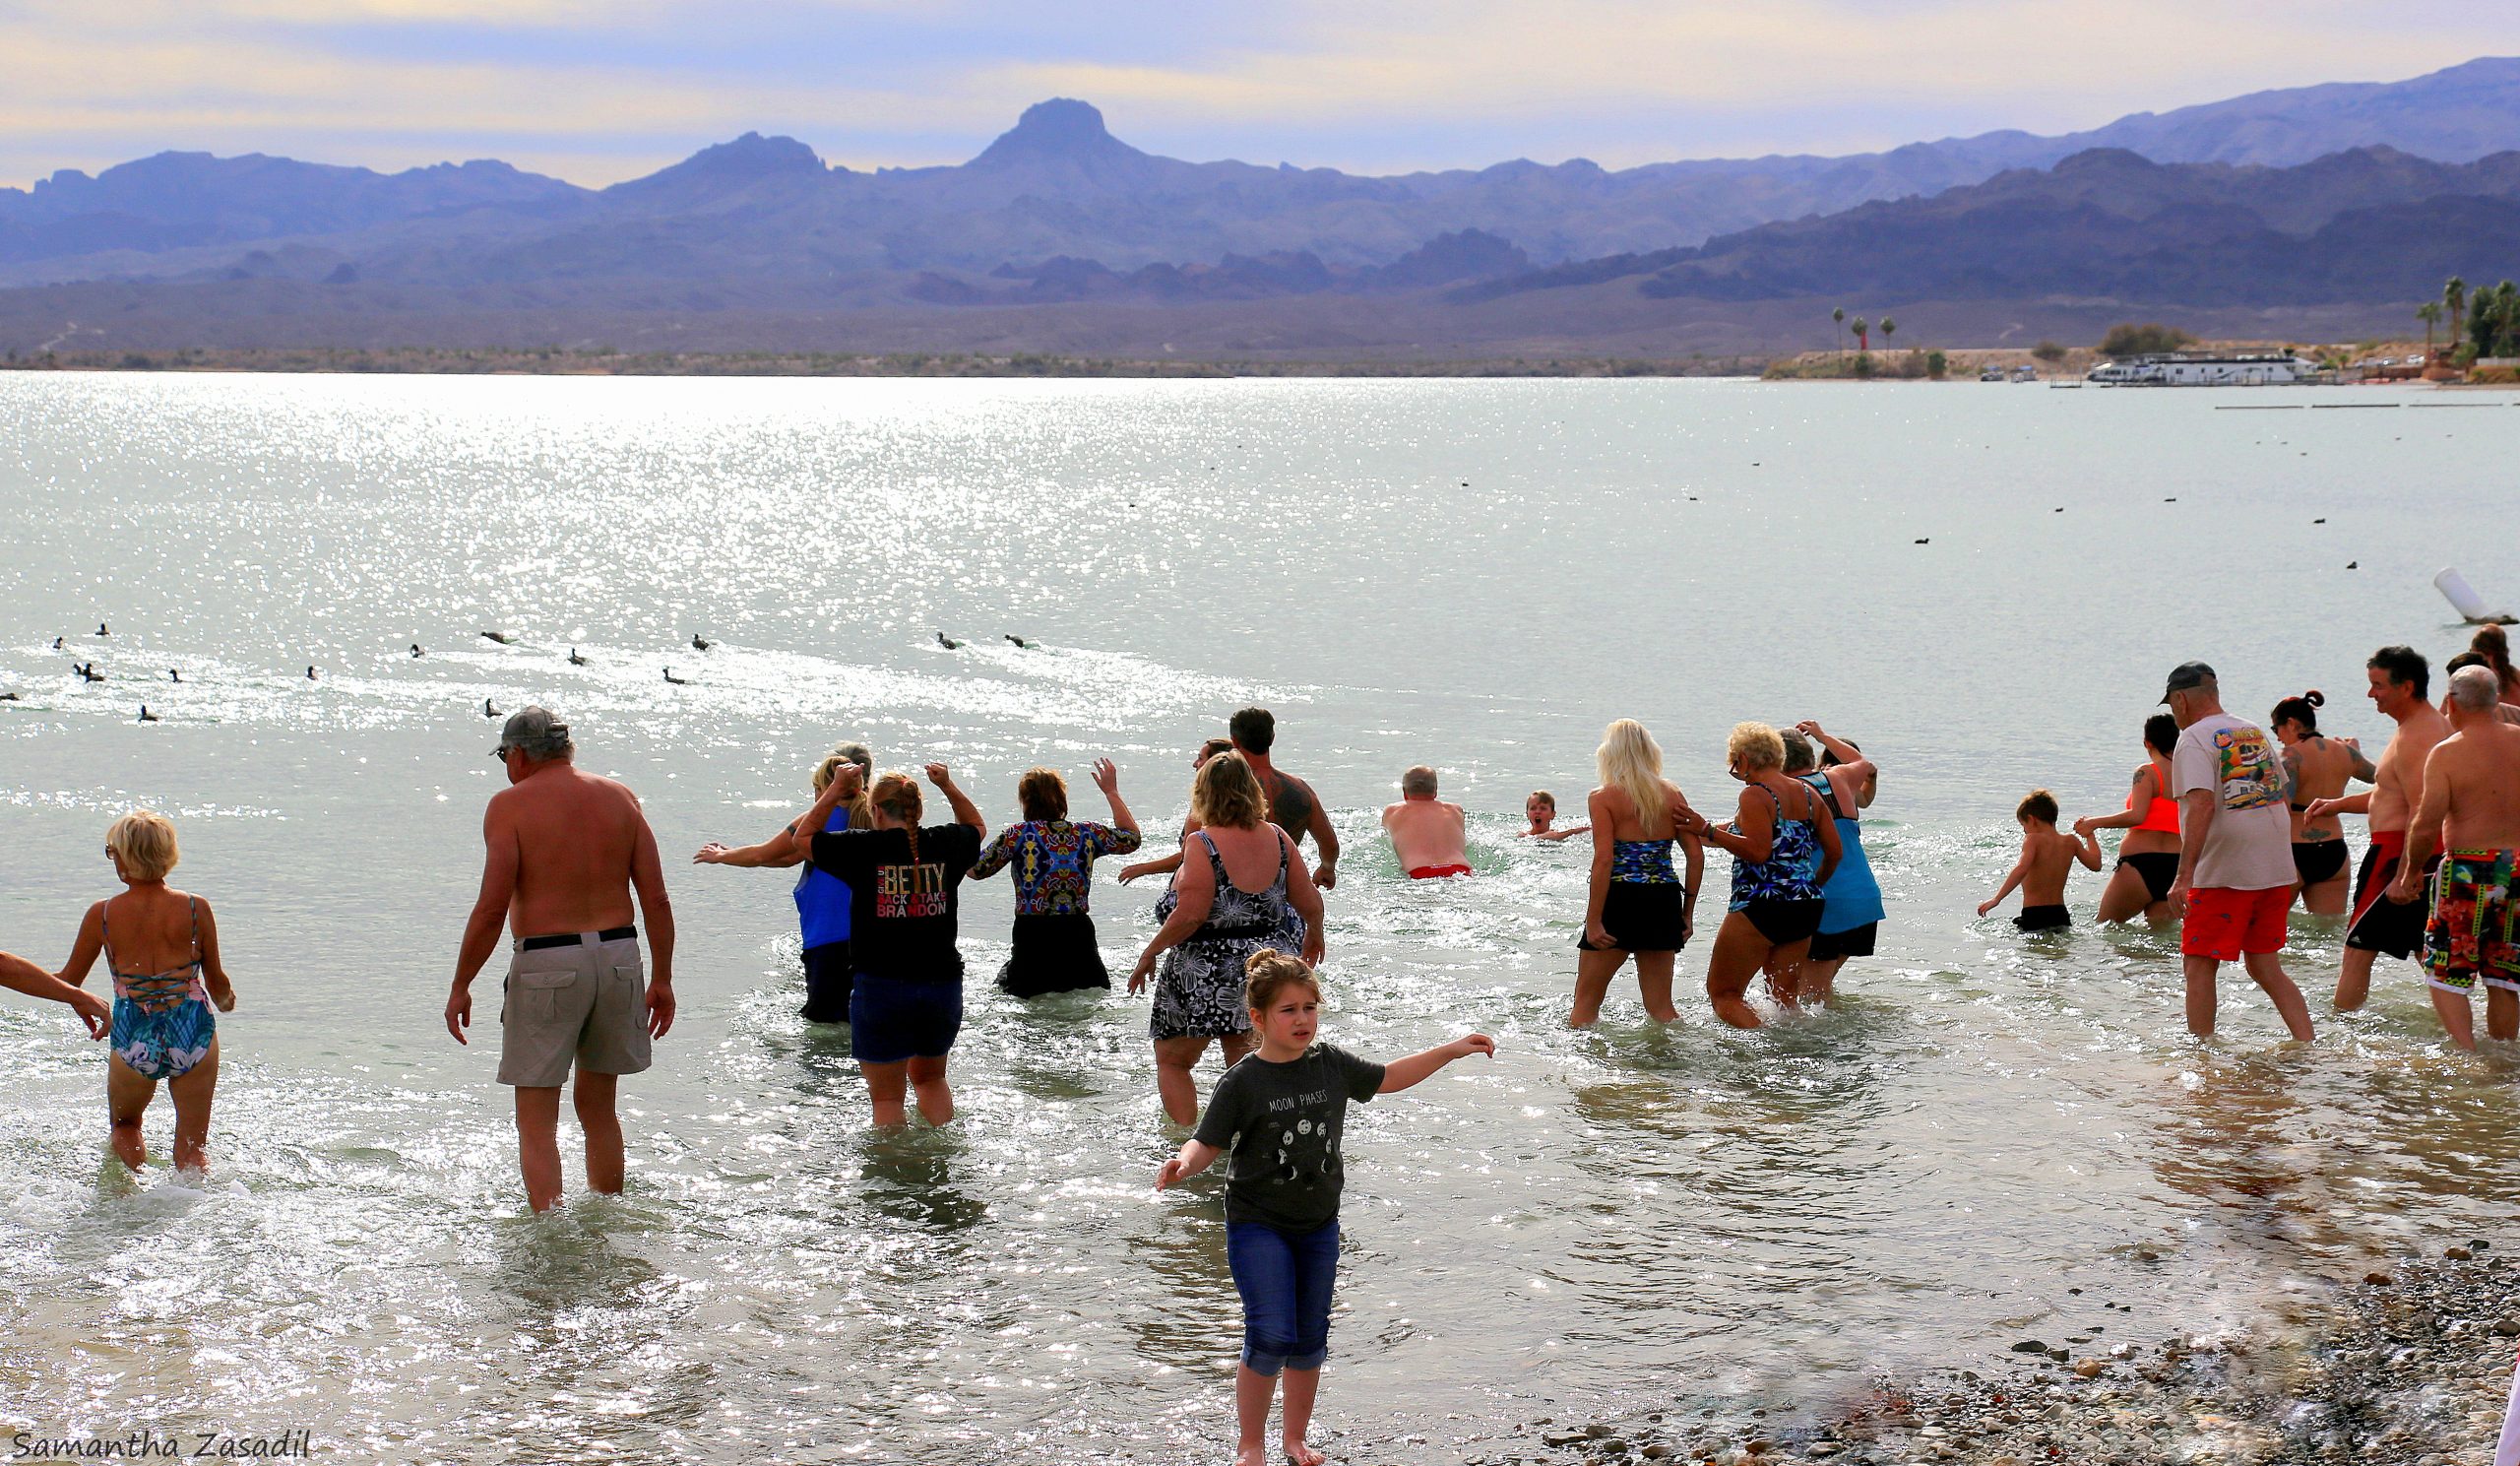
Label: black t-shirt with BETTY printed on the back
xmin=809 ymin=824 xmax=982 ymax=983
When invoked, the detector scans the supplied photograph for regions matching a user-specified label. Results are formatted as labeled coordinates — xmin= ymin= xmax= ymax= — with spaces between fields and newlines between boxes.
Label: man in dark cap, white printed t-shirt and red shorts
xmin=2162 ymin=663 xmax=2311 ymax=1043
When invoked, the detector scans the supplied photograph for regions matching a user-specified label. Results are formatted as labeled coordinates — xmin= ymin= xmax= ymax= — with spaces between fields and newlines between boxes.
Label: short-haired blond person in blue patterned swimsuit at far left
xmin=60 ymin=808 xmax=237 ymax=1172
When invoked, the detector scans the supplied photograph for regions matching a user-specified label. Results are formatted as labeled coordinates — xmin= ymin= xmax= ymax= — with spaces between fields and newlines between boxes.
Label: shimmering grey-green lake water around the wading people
xmin=0 ymin=373 xmax=2520 ymax=1461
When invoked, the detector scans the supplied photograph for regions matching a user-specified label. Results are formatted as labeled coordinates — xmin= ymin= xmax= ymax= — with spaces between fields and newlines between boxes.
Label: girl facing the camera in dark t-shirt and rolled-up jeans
xmin=1154 ymin=947 xmax=1497 ymax=1466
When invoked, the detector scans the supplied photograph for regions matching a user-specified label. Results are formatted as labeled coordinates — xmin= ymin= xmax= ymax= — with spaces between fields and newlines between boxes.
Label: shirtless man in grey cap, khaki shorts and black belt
xmin=446 ymin=708 xmax=673 ymax=1212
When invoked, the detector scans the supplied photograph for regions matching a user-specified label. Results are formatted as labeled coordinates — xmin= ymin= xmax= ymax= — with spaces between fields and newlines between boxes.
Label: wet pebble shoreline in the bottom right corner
xmin=1420 ymin=1242 xmax=2520 ymax=1466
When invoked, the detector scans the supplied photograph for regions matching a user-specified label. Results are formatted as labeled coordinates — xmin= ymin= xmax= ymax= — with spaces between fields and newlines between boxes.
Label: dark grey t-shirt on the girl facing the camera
xmin=1197 ymin=1048 xmax=1391 ymax=1232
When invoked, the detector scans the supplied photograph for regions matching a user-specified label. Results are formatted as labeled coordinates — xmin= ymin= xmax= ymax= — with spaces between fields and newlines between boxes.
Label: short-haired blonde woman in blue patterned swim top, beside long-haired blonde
xmin=1681 ymin=723 xmax=1840 ymax=1028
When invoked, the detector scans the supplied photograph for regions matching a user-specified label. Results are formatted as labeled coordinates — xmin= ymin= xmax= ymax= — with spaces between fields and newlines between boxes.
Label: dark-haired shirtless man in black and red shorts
xmin=2300 ymin=648 xmax=2449 ymax=1012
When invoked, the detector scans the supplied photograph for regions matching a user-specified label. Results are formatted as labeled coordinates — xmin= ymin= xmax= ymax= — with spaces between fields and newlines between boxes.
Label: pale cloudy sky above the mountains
xmin=0 ymin=0 xmax=2520 ymax=186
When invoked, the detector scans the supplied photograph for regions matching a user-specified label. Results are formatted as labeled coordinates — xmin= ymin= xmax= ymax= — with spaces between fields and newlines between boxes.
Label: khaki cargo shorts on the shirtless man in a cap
xmin=499 ymin=932 xmax=650 ymax=1088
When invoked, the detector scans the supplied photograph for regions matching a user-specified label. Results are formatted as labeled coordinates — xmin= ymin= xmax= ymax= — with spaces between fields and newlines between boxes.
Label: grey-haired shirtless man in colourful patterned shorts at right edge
xmin=2389 ymin=668 xmax=2520 ymax=1048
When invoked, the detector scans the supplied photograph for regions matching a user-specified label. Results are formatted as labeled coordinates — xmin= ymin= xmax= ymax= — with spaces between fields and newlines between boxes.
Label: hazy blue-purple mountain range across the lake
xmin=0 ymin=58 xmax=2520 ymax=355
